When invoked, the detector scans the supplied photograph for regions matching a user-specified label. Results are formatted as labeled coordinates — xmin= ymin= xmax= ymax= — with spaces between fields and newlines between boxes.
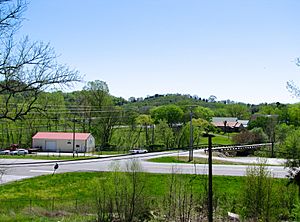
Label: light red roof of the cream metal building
xmin=32 ymin=132 xmax=91 ymax=140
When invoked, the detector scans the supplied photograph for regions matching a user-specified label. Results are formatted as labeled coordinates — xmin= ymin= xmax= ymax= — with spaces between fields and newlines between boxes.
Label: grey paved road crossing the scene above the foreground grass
xmin=0 ymin=151 xmax=287 ymax=183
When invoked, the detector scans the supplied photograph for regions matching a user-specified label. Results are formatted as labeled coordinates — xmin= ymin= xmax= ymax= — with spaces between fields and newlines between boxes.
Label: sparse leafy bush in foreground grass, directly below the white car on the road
xmin=94 ymin=160 xmax=150 ymax=221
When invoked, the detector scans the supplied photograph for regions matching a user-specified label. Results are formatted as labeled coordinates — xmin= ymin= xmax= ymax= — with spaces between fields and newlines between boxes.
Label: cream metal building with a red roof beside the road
xmin=32 ymin=132 xmax=95 ymax=152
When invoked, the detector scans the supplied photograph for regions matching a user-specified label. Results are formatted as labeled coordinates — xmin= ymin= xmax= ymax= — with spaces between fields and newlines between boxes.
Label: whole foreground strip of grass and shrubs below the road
xmin=0 ymin=162 xmax=300 ymax=221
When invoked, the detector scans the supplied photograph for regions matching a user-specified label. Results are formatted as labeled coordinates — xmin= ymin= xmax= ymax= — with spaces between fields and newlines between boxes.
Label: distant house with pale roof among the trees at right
xmin=212 ymin=117 xmax=248 ymax=132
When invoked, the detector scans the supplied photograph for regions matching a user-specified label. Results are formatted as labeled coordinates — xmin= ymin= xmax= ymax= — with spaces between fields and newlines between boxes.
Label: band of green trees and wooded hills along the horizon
xmin=0 ymin=80 xmax=300 ymax=153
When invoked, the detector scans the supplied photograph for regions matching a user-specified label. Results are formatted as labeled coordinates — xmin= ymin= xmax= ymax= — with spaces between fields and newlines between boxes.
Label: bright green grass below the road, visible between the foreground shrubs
xmin=0 ymin=168 xmax=287 ymax=221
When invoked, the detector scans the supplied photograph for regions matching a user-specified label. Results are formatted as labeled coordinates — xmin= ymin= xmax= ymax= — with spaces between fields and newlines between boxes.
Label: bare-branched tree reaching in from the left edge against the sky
xmin=0 ymin=0 xmax=81 ymax=121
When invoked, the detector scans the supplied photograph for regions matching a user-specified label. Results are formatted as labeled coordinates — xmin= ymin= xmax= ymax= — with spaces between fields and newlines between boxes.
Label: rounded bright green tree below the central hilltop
xmin=150 ymin=105 xmax=183 ymax=126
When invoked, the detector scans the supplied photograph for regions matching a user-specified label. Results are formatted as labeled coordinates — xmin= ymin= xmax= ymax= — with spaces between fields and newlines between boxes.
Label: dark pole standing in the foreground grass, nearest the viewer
xmin=203 ymin=133 xmax=214 ymax=222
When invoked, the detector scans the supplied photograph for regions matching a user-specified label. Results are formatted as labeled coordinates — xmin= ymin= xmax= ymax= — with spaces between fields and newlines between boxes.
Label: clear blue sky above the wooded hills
xmin=20 ymin=0 xmax=300 ymax=103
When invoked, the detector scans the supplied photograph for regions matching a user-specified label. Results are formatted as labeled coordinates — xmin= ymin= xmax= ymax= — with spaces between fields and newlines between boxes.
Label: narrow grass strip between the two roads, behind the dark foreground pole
xmin=148 ymin=156 xmax=278 ymax=166
